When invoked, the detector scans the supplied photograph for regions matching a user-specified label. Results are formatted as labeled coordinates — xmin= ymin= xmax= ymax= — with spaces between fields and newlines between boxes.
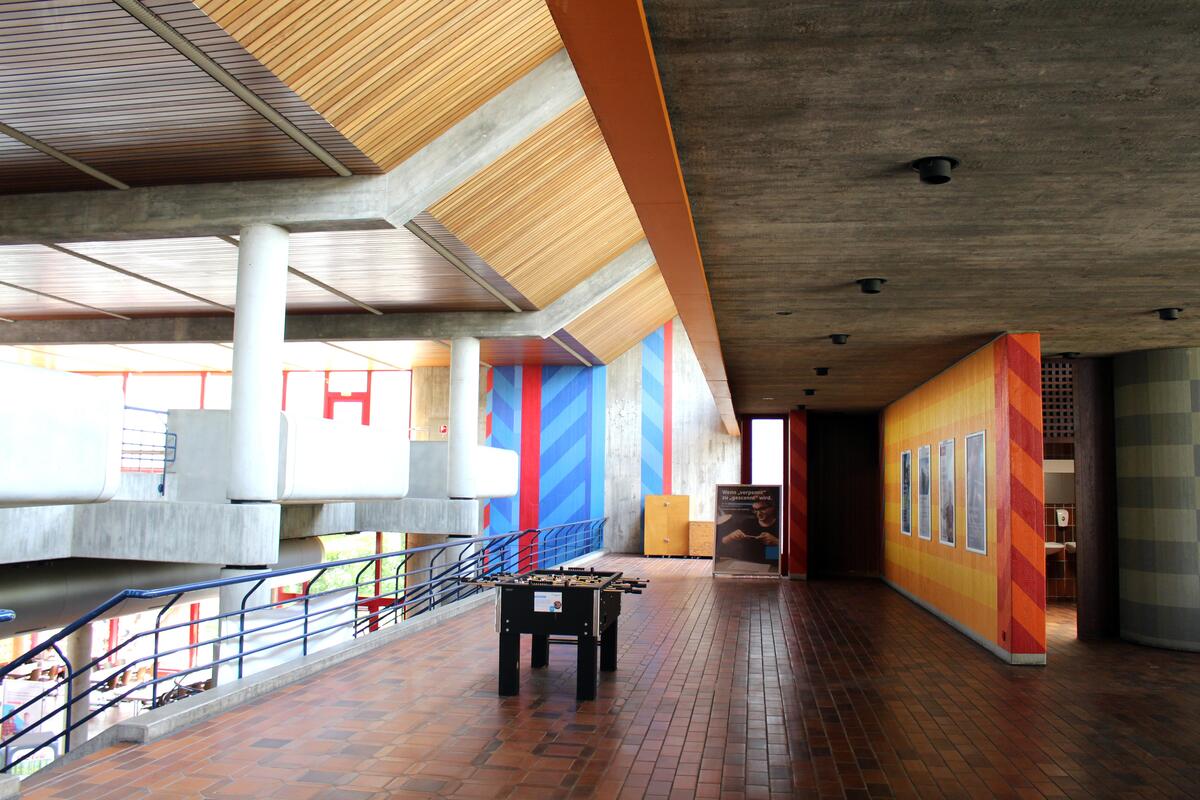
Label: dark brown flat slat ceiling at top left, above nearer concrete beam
xmin=0 ymin=0 xmax=376 ymax=193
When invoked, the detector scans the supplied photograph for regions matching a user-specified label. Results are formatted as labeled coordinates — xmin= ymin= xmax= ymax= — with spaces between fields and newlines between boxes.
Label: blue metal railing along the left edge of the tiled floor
xmin=0 ymin=518 xmax=606 ymax=772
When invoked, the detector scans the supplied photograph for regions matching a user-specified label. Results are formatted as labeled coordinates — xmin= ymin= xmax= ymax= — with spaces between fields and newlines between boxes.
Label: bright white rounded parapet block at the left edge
xmin=0 ymin=363 xmax=125 ymax=506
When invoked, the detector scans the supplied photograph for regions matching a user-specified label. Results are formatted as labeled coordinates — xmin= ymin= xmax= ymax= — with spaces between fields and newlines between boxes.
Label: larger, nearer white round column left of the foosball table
xmin=228 ymin=224 xmax=288 ymax=503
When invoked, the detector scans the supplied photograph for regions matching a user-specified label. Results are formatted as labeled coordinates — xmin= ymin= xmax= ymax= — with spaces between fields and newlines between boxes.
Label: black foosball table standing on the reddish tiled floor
xmin=463 ymin=567 xmax=646 ymax=700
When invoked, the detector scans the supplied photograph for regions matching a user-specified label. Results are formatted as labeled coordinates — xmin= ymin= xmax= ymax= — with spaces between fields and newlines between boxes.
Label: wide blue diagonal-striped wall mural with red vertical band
xmin=484 ymin=365 xmax=605 ymax=569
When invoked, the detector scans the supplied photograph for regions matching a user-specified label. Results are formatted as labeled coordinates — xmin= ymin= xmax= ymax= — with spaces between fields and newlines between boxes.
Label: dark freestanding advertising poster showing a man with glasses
xmin=713 ymin=486 xmax=782 ymax=576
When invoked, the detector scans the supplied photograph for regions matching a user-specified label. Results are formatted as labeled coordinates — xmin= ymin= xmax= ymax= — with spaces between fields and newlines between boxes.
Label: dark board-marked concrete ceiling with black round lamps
xmin=644 ymin=0 xmax=1200 ymax=411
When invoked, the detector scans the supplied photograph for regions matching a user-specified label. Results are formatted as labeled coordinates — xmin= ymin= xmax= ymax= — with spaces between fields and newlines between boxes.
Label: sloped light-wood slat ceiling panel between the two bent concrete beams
xmin=430 ymin=100 xmax=643 ymax=308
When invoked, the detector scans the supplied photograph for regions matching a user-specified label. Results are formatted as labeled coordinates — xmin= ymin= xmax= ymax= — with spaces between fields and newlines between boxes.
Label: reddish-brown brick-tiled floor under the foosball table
xmin=16 ymin=558 xmax=1200 ymax=800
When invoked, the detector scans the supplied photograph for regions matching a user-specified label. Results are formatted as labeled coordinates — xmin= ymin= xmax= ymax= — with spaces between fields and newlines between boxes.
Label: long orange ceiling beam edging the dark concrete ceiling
xmin=546 ymin=0 xmax=738 ymax=434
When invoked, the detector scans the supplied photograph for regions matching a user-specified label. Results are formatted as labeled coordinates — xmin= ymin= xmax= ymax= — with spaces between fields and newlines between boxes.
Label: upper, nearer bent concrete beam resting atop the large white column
xmin=0 ymin=50 xmax=583 ymax=245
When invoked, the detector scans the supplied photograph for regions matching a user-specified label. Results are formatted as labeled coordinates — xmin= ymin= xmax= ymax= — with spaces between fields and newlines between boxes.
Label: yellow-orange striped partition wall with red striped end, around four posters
xmin=881 ymin=333 xmax=1045 ymax=663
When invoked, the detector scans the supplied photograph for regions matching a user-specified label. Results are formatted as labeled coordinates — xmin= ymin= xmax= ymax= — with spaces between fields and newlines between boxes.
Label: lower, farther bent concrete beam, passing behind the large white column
xmin=0 ymin=239 xmax=654 ymax=344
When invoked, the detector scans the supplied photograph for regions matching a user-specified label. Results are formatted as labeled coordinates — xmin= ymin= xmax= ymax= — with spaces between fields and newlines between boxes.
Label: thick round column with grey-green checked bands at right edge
xmin=1108 ymin=348 xmax=1200 ymax=650
